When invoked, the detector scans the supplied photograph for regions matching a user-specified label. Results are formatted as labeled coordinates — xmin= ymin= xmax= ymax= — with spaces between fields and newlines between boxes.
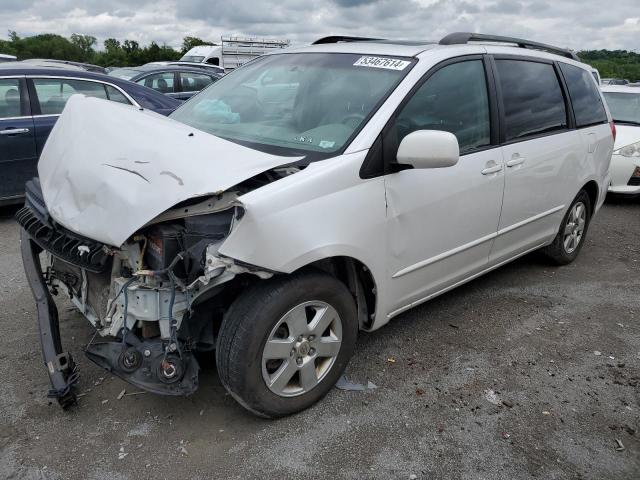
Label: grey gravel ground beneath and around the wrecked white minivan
xmin=0 ymin=200 xmax=640 ymax=480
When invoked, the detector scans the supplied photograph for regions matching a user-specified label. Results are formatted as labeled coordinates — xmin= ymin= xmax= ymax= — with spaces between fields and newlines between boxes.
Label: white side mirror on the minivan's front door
xmin=396 ymin=130 xmax=460 ymax=168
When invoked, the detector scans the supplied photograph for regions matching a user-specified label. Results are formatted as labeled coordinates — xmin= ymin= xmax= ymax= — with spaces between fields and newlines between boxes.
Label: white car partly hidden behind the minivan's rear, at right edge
xmin=602 ymin=85 xmax=640 ymax=195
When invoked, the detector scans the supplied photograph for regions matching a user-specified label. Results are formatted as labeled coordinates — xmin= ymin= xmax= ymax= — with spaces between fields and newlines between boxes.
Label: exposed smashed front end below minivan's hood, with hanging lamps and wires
xmin=45 ymin=207 xmax=250 ymax=395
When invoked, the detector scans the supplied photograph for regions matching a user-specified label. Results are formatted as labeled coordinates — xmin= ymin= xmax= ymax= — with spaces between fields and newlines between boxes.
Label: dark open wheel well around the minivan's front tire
xmin=302 ymin=257 xmax=376 ymax=329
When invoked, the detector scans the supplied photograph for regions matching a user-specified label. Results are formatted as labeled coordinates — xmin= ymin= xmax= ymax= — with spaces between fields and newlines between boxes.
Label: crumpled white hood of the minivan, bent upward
xmin=38 ymin=95 xmax=297 ymax=246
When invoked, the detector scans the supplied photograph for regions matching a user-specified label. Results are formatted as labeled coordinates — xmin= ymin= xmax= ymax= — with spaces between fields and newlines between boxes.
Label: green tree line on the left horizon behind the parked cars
xmin=0 ymin=31 xmax=212 ymax=67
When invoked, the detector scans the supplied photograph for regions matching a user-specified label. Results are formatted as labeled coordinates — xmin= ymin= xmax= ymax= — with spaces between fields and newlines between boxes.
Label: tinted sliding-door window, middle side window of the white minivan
xmin=496 ymin=60 xmax=567 ymax=141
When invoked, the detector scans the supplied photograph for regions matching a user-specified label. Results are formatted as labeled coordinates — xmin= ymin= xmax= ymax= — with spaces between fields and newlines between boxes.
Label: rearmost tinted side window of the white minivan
xmin=560 ymin=63 xmax=607 ymax=128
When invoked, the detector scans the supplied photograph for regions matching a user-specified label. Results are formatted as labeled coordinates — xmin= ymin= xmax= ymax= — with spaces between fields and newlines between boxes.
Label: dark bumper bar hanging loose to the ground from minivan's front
xmin=20 ymin=230 xmax=78 ymax=409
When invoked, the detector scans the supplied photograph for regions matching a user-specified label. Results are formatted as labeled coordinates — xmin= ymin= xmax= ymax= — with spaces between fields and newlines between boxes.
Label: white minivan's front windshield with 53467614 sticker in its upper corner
xmin=171 ymin=53 xmax=412 ymax=155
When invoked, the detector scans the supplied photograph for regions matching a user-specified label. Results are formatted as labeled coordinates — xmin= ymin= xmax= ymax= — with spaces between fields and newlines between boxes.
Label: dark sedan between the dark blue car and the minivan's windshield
xmin=109 ymin=64 xmax=222 ymax=100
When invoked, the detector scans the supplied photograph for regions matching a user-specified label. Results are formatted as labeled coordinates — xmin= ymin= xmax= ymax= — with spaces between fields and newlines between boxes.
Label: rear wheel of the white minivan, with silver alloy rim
xmin=542 ymin=190 xmax=592 ymax=265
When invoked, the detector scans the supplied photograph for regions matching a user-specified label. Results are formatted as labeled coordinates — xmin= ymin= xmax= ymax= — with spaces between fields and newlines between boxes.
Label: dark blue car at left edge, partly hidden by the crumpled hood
xmin=0 ymin=64 xmax=181 ymax=205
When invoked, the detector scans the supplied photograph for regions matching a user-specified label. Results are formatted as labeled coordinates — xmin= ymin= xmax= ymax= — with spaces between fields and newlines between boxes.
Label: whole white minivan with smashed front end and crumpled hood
xmin=17 ymin=33 xmax=615 ymax=417
